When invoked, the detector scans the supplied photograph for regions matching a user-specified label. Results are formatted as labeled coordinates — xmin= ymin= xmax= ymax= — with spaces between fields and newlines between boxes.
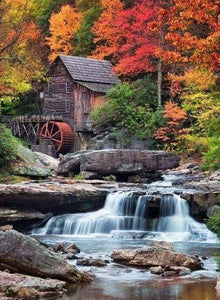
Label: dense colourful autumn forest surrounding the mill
xmin=0 ymin=0 xmax=220 ymax=170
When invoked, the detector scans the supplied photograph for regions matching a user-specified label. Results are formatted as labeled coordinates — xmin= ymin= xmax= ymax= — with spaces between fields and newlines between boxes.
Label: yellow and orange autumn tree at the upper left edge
xmin=0 ymin=0 xmax=44 ymax=101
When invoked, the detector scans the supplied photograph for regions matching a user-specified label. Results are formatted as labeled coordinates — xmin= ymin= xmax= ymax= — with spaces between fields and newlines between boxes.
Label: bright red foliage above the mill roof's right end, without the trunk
xmin=93 ymin=0 xmax=161 ymax=75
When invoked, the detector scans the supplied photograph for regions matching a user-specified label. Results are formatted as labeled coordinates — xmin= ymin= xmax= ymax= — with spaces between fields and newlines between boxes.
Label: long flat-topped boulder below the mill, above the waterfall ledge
xmin=58 ymin=149 xmax=180 ymax=175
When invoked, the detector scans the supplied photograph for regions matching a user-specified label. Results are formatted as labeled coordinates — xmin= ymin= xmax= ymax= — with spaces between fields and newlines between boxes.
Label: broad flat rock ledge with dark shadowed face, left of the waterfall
xmin=0 ymin=179 xmax=109 ymax=216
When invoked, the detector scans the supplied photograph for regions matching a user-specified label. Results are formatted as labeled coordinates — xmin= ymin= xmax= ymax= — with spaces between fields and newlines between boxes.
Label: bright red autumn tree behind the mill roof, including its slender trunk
xmin=93 ymin=0 xmax=171 ymax=106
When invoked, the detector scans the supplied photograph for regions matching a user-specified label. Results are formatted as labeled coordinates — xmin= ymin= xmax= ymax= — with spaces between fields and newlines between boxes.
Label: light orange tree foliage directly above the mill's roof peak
xmin=46 ymin=5 xmax=82 ymax=61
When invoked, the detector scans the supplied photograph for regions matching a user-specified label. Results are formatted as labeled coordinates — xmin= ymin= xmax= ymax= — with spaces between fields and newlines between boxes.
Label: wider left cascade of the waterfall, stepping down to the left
xmin=33 ymin=192 xmax=147 ymax=235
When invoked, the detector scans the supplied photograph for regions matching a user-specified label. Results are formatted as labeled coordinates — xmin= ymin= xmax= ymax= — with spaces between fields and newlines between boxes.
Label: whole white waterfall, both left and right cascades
xmin=32 ymin=191 xmax=216 ymax=241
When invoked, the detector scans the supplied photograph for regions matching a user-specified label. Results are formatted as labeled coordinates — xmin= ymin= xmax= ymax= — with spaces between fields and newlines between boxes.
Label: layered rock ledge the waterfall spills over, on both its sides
xmin=0 ymin=170 xmax=220 ymax=231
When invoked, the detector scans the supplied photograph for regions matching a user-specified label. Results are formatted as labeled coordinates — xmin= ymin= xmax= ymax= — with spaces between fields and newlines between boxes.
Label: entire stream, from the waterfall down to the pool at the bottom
xmin=32 ymin=176 xmax=220 ymax=300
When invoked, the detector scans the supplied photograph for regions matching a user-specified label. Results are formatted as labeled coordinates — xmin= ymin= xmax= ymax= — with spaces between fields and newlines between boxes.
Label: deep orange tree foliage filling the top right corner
xmin=161 ymin=0 xmax=219 ymax=69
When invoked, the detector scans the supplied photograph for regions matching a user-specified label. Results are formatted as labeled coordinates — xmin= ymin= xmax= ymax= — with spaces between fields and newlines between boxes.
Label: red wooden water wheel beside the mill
xmin=39 ymin=121 xmax=73 ymax=153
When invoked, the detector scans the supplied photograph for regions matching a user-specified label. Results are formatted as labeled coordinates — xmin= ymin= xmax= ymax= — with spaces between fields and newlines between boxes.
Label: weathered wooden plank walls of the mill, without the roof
xmin=44 ymin=60 xmax=102 ymax=132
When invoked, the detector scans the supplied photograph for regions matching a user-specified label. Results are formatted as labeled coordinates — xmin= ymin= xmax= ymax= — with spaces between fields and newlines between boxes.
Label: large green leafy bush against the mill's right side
xmin=92 ymin=77 xmax=163 ymax=139
